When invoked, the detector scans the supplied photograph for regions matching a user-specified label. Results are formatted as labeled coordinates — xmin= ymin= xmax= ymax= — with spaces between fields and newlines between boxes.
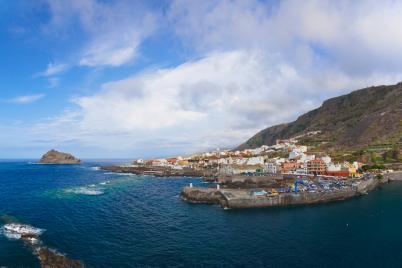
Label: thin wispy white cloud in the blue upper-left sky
xmin=46 ymin=0 xmax=157 ymax=67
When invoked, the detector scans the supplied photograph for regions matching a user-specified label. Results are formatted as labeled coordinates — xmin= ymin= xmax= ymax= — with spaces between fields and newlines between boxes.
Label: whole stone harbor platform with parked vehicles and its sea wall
xmin=181 ymin=175 xmax=389 ymax=209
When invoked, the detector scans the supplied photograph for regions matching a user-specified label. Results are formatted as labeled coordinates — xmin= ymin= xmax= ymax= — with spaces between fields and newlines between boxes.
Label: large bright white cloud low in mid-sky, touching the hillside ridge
xmin=25 ymin=50 xmax=402 ymax=155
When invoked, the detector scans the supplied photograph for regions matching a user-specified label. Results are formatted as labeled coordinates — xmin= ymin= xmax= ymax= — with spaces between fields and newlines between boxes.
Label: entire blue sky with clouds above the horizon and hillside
xmin=0 ymin=0 xmax=402 ymax=159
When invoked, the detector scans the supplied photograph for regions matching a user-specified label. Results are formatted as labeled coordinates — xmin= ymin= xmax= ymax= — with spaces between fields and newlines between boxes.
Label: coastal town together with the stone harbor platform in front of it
xmin=104 ymin=138 xmax=398 ymax=208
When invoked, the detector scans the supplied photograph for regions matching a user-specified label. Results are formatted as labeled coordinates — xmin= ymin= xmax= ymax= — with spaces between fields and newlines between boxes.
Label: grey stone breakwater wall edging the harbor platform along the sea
xmin=181 ymin=178 xmax=388 ymax=208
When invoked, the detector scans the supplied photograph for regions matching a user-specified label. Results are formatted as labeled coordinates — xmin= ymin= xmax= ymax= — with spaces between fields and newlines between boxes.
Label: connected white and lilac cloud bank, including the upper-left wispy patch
xmin=11 ymin=0 xmax=402 ymax=156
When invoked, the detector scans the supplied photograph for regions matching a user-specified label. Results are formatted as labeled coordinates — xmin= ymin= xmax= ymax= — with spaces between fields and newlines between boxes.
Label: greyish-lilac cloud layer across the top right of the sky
xmin=169 ymin=0 xmax=402 ymax=76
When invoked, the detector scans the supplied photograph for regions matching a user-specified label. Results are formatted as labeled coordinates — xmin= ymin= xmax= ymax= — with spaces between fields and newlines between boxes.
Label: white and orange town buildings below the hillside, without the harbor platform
xmin=107 ymin=139 xmax=370 ymax=180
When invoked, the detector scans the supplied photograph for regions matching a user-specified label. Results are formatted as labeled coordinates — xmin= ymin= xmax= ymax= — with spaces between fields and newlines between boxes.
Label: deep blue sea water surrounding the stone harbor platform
xmin=0 ymin=161 xmax=402 ymax=267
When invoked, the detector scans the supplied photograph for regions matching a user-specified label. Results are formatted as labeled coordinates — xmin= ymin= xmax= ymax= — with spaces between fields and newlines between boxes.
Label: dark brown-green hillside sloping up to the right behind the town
xmin=238 ymin=83 xmax=402 ymax=149
